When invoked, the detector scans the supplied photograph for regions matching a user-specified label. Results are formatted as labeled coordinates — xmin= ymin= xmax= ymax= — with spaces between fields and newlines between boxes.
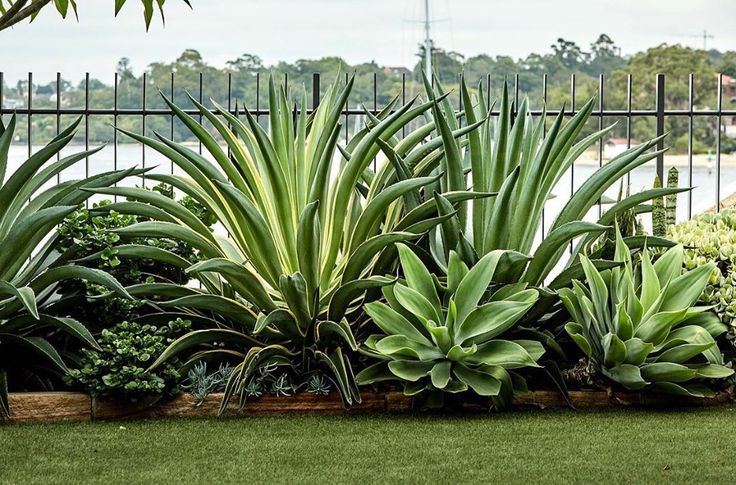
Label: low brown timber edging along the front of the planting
xmin=0 ymin=391 xmax=732 ymax=424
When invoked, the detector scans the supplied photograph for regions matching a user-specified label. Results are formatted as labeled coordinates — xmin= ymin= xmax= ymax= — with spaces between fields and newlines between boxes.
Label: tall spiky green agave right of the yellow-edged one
xmin=394 ymin=79 xmax=688 ymax=287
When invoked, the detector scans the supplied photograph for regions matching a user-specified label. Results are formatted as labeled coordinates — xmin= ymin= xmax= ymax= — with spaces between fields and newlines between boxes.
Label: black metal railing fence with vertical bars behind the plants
xmin=0 ymin=72 xmax=736 ymax=218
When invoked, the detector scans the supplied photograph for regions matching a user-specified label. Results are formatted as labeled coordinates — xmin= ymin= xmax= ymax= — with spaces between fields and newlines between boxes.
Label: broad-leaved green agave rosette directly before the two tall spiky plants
xmin=357 ymin=244 xmax=544 ymax=407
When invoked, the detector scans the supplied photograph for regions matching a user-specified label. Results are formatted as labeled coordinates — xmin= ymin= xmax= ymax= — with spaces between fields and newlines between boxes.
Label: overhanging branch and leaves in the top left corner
xmin=0 ymin=0 xmax=192 ymax=31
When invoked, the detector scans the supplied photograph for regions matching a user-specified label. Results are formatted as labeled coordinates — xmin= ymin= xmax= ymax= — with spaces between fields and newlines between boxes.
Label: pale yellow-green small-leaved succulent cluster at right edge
xmin=668 ymin=209 xmax=736 ymax=344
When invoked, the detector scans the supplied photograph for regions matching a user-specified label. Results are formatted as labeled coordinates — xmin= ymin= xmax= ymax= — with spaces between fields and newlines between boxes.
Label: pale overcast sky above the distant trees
xmin=0 ymin=0 xmax=736 ymax=83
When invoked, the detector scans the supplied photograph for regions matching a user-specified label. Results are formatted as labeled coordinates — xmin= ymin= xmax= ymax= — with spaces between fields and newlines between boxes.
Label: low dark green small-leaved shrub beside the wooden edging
xmin=67 ymin=318 xmax=191 ymax=397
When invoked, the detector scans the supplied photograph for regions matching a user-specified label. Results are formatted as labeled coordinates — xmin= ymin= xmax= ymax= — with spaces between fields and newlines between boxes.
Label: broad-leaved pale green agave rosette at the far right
xmin=559 ymin=232 xmax=733 ymax=397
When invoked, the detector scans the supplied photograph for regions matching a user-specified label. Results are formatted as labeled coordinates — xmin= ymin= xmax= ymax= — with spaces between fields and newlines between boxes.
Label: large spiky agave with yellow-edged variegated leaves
xmin=93 ymin=76 xmax=473 ymax=406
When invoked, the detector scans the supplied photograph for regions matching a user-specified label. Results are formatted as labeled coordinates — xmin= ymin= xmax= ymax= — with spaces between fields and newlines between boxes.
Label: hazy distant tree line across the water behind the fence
xmin=3 ymin=34 xmax=736 ymax=152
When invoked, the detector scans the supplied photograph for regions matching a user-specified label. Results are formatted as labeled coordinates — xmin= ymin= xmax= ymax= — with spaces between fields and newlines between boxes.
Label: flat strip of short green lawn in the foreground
xmin=0 ymin=408 xmax=736 ymax=484
